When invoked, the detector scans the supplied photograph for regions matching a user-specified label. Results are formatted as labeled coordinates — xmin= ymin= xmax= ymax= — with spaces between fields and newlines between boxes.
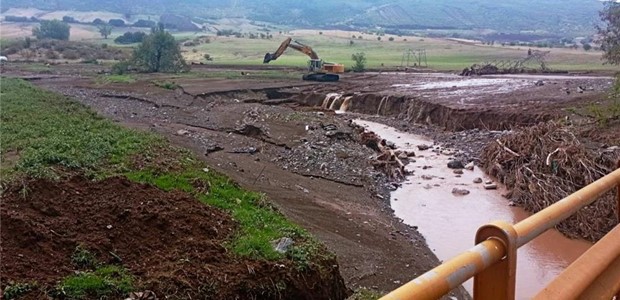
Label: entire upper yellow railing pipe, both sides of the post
xmin=381 ymin=163 xmax=620 ymax=300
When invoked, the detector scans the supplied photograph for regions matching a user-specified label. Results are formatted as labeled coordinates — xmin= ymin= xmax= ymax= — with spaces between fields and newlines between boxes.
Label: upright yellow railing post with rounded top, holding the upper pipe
xmin=474 ymin=221 xmax=517 ymax=300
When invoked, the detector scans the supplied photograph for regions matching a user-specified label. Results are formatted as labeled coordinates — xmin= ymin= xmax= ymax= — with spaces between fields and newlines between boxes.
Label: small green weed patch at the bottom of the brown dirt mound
xmin=56 ymin=266 xmax=133 ymax=299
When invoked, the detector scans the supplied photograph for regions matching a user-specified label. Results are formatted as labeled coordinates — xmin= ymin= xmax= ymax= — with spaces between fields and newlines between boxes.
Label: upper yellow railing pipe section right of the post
xmin=515 ymin=169 xmax=620 ymax=247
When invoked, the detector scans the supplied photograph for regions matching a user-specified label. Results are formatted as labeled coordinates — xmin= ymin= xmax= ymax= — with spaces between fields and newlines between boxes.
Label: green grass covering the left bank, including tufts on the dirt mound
xmin=0 ymin=78 xmax=331 ymax=298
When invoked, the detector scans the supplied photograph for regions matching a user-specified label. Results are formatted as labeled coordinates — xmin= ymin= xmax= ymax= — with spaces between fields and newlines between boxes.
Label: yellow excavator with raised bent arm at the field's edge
xmin=263 ymin=37 xmax=344 ymax=82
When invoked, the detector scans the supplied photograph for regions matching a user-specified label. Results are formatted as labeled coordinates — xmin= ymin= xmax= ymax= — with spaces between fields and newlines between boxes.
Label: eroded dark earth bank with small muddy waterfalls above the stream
xmin=295 ymin=93 xmax=556 ymax=131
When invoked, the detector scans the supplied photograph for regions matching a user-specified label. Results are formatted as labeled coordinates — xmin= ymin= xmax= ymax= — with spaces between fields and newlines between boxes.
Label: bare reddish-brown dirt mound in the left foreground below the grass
xmin=0 ymin=177 xmax=346 ymax=299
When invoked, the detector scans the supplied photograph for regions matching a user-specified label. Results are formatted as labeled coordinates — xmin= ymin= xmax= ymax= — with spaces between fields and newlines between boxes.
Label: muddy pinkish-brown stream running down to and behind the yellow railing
xmin=355 ymin=120 xmax=590 ymax=299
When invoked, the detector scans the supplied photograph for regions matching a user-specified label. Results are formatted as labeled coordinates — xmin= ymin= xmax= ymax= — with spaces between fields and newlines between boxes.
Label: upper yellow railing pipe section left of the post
xmin=381 ymin=239 xmax=506 ymax=300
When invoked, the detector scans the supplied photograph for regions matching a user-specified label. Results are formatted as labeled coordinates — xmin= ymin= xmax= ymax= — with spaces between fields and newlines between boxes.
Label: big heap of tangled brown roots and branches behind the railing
xmin=482 ymin=122 xmax=620 ymax=241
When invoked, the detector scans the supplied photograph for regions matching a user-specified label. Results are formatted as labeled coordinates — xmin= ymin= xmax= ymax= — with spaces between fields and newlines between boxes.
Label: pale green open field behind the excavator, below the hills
xmin=2 ymin=23 xmax=615 ymax=71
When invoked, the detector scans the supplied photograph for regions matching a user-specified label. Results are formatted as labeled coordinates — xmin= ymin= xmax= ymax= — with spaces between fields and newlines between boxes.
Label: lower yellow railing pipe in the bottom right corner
xmin=535 ymin=225 xmax=620 ymax=299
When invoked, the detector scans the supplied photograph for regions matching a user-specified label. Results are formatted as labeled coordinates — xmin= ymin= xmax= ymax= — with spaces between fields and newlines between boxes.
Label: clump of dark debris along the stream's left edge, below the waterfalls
xmin=361 ymin=132 xmax=415 ymax=181
